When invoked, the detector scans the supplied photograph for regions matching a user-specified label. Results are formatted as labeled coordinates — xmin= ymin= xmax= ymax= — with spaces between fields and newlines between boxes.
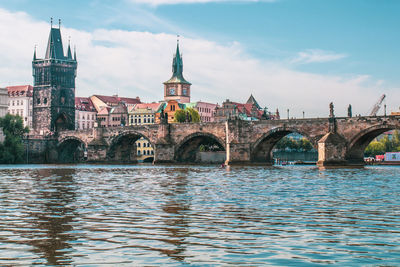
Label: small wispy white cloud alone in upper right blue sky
xmin=292 ymin=49 xmax=347 ymax=64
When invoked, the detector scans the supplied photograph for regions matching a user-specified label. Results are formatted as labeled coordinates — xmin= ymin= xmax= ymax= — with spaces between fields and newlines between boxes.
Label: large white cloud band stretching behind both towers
xmin=0 ymin=9 xmax=400 ymax=117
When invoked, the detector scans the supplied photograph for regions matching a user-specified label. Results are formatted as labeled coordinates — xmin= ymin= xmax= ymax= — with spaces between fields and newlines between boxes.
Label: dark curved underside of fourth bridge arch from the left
xmin=250 ymin=127 xmax=319 ymax=163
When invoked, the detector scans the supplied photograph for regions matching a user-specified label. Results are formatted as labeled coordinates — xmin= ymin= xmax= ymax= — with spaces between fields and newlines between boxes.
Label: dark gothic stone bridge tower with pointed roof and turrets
xmin=32 ymin=19 xmax=77 ymax=135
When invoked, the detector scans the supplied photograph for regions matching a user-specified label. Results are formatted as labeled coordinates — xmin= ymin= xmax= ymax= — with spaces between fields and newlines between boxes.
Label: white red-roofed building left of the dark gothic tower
xmin=7 ymin=85 xmax=33 ymax=128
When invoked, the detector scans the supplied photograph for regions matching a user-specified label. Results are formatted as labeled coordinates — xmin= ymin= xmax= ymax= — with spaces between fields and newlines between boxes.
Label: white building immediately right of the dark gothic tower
xmin=75 ymin=97 xmax=97 ymax=130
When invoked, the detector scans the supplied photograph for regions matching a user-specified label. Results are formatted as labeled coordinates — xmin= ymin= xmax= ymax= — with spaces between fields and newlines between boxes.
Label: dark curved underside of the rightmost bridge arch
xmin=345 ymin=124 xmax=400 ymax=164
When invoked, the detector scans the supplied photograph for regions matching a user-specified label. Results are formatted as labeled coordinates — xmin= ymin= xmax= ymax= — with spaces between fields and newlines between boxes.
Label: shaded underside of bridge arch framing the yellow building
xmin=107 ymin=131 xmax=155 ymax=163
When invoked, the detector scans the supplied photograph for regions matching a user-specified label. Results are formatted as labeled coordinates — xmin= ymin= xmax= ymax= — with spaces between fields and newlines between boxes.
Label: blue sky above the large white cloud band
xmin=0 ymin=0 xmax=400 ymax=115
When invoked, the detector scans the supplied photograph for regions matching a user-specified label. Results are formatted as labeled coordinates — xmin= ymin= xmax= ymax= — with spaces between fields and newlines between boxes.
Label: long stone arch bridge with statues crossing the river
xmin=57 ymin=116 xmax=400 ymax=166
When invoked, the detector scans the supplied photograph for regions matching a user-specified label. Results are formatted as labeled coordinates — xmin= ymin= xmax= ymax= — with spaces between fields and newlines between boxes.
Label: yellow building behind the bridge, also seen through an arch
xmin=128 ymin=103 xmax=161 ymax=162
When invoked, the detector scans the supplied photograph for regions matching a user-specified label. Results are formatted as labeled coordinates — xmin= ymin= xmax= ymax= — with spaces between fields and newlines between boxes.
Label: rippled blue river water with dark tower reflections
xmin=0 ymin=165 xmax=400 ymax=266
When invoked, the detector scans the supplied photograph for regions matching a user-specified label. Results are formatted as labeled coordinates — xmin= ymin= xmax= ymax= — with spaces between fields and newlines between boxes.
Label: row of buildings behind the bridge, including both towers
xmin=0 ymin=22 xmax=279 ymax=161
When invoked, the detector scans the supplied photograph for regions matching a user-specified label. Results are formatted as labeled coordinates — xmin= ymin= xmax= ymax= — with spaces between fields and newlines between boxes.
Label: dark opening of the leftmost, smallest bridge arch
xmin=57 ymin=136 xmax=87 ymax=163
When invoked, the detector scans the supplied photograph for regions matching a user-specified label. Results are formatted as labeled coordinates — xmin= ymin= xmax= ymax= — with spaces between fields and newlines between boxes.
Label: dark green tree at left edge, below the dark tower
xmin=0 ymin=114 xmax=29 ymax=164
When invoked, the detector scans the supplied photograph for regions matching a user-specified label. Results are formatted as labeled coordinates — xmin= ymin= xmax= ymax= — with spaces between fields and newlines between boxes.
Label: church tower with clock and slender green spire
xmin=164 ymin=40 xmax=192 ymax=103
